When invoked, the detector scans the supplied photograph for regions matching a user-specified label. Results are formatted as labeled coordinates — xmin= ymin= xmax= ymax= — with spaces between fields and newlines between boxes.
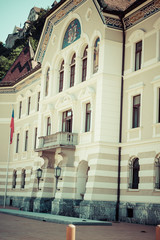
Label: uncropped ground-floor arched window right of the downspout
xmin=129 ymin=158 xmax=140 ymax=189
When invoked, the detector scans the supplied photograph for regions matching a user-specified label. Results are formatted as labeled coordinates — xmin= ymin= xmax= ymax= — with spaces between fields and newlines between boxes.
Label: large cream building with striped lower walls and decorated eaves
xmin=0 ymin=0 xmax=160 ymax=224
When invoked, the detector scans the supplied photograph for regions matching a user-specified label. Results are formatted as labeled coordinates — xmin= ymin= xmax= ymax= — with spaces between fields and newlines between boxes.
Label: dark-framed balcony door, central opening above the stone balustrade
xmin=62 ymin=110 xmax=72 ymax=132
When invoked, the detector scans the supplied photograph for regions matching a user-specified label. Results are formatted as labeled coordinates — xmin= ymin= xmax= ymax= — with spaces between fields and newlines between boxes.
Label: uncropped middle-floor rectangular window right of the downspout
xmin=132 ymin=95 xmax=141 ymax=128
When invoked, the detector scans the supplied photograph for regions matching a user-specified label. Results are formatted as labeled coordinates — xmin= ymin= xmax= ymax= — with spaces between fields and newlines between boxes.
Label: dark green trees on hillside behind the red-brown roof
xmin=0 ymin=9 xmax=49 ymax=81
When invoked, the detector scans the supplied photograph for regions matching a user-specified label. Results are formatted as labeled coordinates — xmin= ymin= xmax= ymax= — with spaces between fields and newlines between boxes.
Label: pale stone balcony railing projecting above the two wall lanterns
xmin=38 ymin=132 xmax=78 ymax=149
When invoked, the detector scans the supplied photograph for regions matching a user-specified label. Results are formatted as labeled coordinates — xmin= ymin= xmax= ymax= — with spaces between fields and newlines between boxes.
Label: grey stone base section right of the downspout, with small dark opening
xmin=119 ymin=203 xmax=160 ymax=225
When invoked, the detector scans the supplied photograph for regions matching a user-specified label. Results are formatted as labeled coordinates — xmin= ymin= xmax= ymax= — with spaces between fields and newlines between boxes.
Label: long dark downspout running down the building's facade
xmin=115 ymin=16 xmax=125 ymax=221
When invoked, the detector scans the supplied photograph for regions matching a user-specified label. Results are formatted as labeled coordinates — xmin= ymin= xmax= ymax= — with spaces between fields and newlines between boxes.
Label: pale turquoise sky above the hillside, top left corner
xmin=0 ymin=0 xmax=54 ymax=43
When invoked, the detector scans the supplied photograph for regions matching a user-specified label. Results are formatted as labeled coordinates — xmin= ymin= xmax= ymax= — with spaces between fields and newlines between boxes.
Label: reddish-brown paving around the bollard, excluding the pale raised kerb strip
xmin=0 ymin=213 xmax=155 ymax=240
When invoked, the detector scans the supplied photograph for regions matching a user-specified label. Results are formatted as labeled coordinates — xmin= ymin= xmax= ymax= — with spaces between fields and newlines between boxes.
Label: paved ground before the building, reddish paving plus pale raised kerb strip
xmin=0 ymin=208 xmax=156 ymax=240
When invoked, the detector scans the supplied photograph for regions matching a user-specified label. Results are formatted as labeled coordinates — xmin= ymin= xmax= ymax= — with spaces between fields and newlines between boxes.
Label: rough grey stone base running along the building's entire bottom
xmin=0 ymin=196 xmax=160 ymax=225
